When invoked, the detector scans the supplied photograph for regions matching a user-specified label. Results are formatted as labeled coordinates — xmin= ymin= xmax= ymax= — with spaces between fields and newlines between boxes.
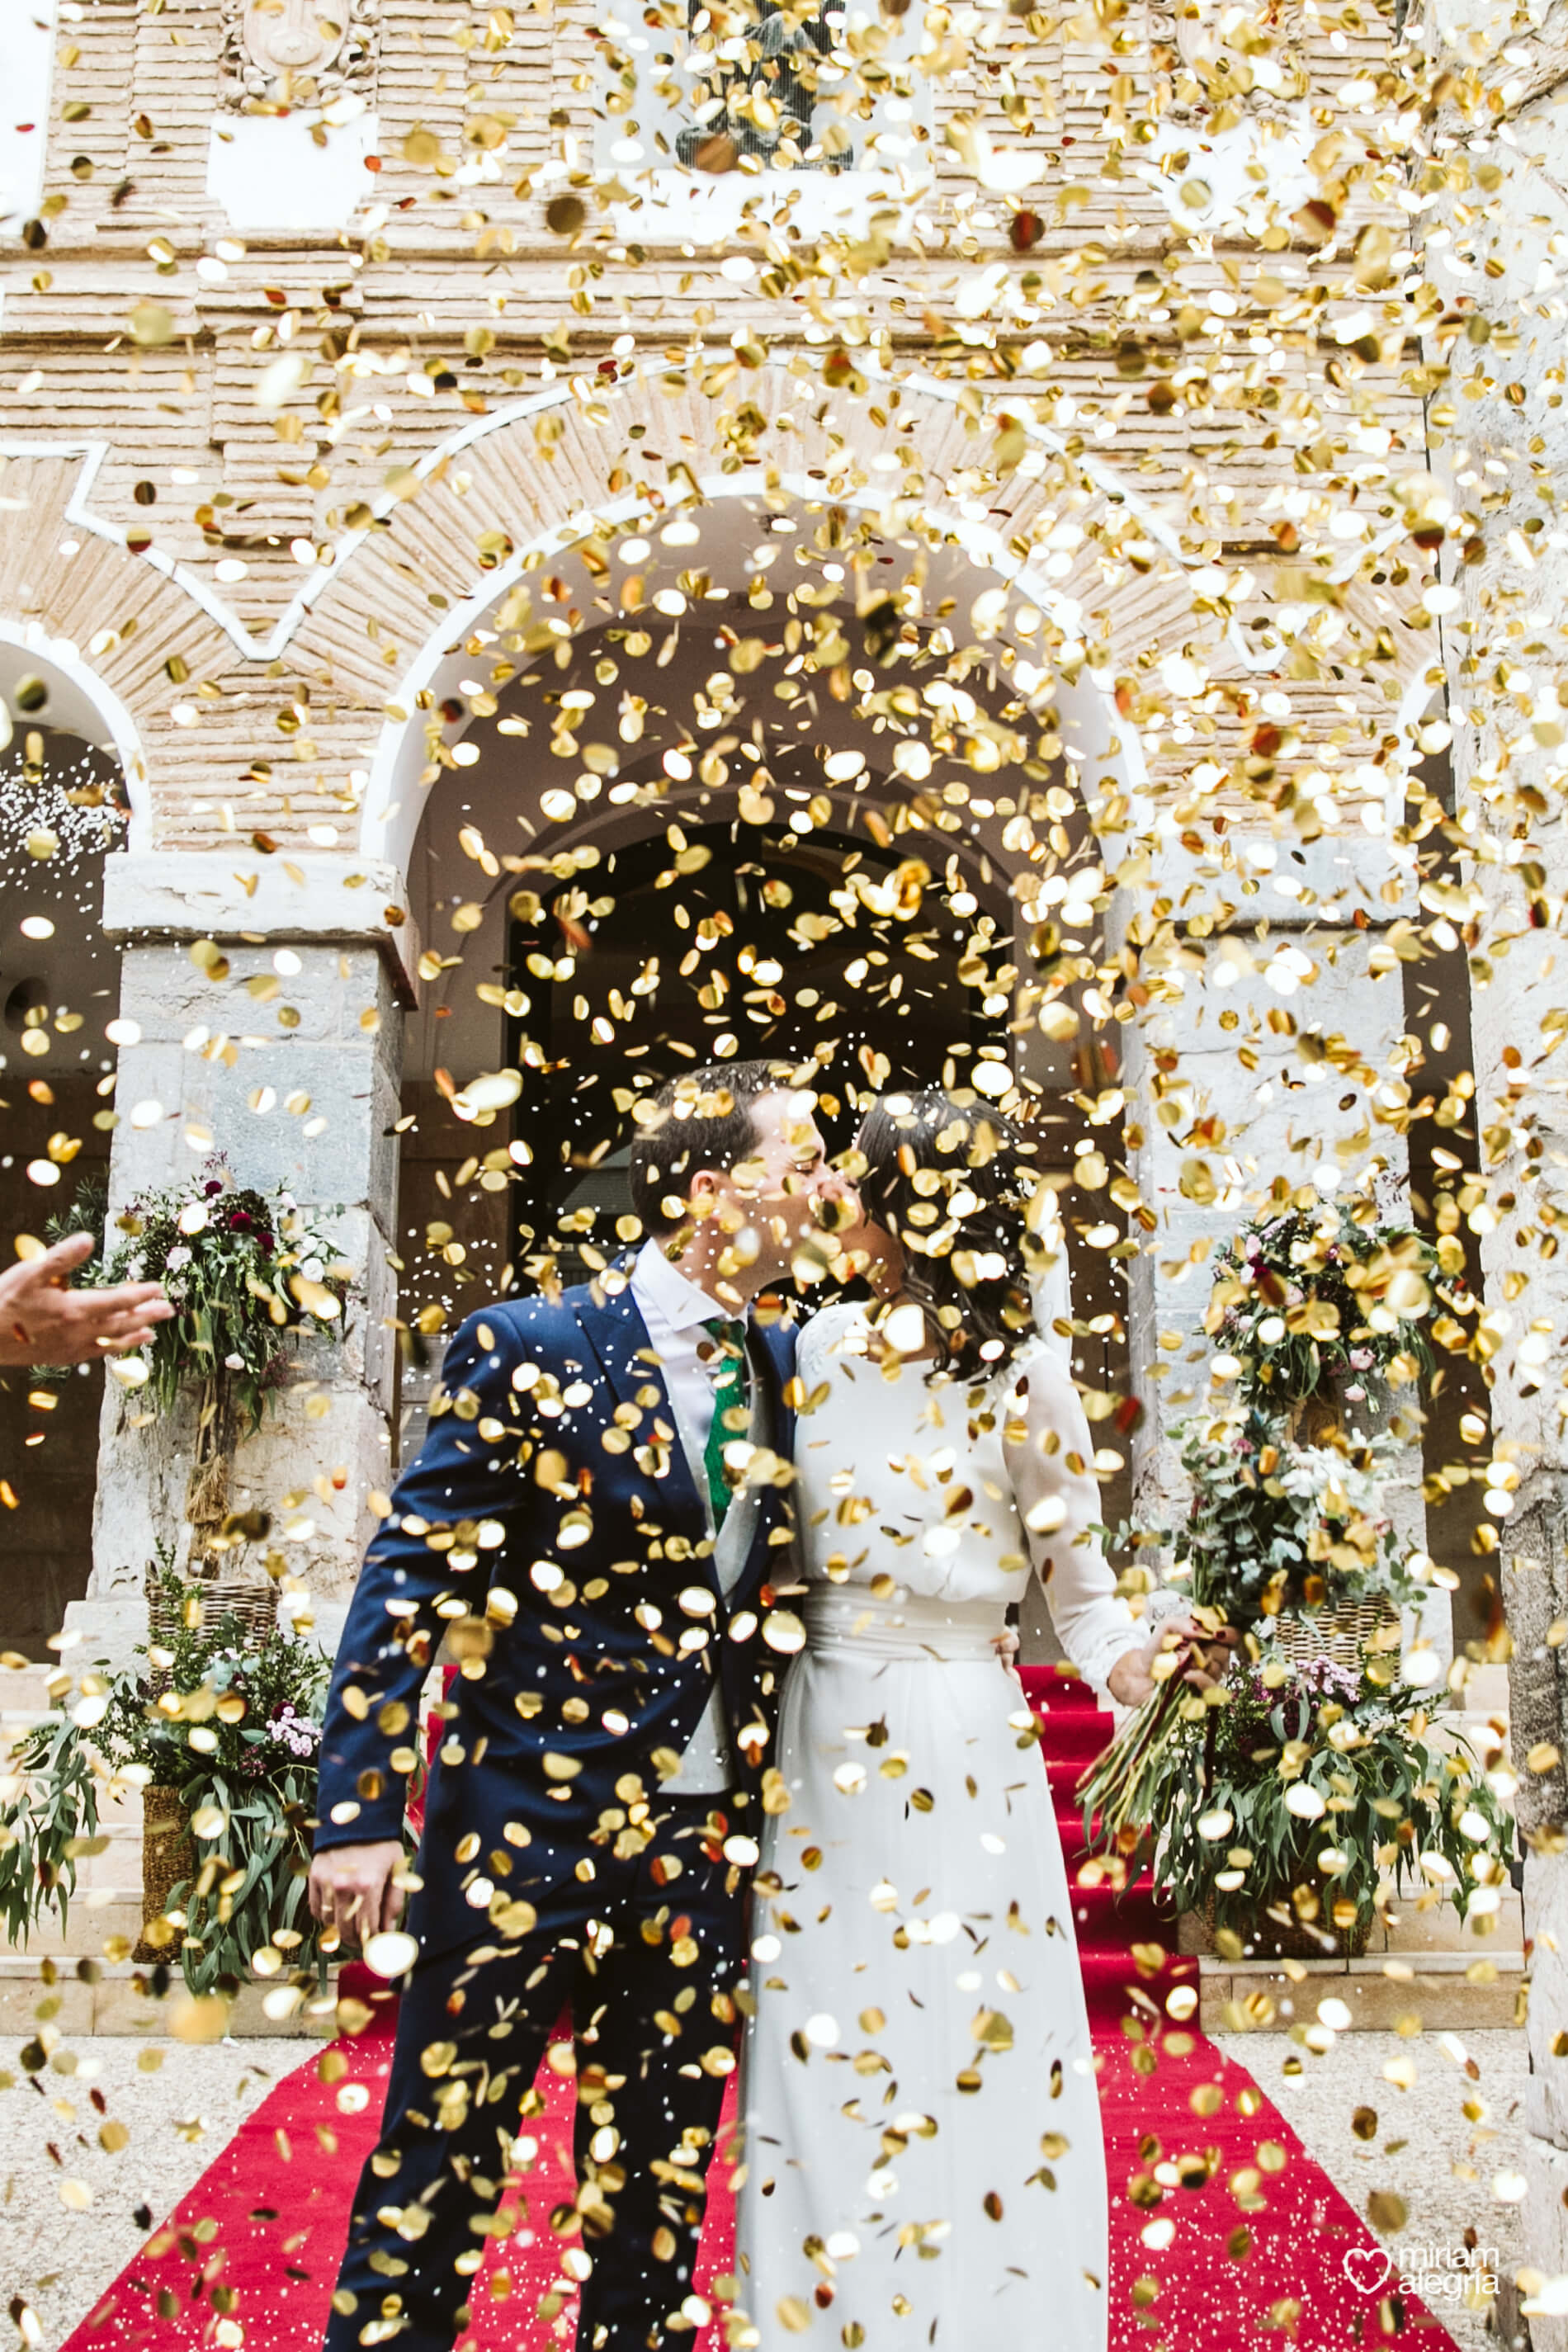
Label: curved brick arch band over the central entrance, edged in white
xmin=245 ymin=365 xmax=1192 ymax=884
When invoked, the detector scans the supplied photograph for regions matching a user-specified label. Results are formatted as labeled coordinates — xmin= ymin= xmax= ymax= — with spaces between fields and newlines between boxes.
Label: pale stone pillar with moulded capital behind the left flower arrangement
xmin=68 ymin=852 xmax=418 ymax=1655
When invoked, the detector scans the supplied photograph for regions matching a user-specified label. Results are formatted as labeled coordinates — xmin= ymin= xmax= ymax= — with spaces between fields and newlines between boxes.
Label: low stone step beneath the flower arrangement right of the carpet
xmin=1199 ymin=1953 xmax=1523 ymax=2039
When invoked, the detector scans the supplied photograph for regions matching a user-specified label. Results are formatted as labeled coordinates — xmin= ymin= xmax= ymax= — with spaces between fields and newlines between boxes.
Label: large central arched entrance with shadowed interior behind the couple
xmin=385 ymin=503 xmax=1131 ymax=1651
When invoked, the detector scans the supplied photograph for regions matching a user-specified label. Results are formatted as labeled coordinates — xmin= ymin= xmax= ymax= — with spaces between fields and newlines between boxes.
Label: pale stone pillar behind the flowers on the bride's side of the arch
xmin=1117 ymin=837 xmax=1452 ymax=1665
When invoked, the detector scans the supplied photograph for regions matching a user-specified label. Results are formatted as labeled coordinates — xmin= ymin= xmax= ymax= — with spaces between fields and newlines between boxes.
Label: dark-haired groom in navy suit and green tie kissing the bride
xmin=310 ymin=1063 xmax=839 ymax=2352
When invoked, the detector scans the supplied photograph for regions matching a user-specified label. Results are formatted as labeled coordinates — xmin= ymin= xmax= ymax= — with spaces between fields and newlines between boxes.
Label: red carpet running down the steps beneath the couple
xmin=64 ymin=1668 xmax=1452 ymax=2352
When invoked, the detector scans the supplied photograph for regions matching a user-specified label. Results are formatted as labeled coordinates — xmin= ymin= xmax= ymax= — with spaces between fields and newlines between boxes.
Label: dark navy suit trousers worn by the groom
xmin=324 ymin=1797 xmax=745 ymax=2352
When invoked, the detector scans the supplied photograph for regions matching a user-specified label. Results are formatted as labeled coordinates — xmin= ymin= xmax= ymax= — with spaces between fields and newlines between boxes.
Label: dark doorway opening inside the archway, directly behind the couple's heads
xmin=508 ymin=824 xmax=1011 ymax=1282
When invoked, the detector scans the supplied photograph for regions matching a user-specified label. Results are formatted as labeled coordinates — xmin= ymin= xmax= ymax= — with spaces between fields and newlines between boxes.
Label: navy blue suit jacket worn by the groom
xmin=315 ymin=1284 xmax=797 ymax=1950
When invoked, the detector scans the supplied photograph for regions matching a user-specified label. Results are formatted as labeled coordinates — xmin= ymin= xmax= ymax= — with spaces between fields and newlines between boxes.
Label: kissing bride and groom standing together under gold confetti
xmin=310 ymin=1063 xmax=1211 ymax=2352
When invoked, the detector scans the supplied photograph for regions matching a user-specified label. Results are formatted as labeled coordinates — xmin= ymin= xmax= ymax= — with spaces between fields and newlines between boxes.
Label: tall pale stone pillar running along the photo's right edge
xmin=1427 ymin=27 xmax=1568 ymax=2314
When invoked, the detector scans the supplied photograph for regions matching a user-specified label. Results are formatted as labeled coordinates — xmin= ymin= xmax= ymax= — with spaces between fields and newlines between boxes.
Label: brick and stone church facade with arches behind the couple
xmin=0 ymin=0 xmax=1568 ymax=2314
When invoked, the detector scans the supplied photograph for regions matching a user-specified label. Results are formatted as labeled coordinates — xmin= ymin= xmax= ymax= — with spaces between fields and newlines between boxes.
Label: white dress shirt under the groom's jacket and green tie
xmin=630 ymin=1242 xmax=759 ymax=1797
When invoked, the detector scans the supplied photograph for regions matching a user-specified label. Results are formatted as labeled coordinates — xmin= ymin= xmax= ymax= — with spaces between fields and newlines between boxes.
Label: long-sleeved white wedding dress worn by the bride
xmin=736 ymin=1306 xmax=1147 ymax=2352
